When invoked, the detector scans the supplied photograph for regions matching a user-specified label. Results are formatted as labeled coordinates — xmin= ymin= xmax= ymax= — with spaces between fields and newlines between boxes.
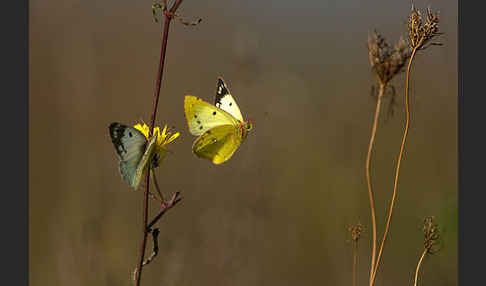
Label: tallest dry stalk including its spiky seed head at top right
xmin=370 ymin=4 xmax=439 ymax=286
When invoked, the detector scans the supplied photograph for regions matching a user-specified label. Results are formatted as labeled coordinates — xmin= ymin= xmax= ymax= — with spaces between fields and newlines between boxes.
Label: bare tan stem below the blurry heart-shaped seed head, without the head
xmin=366 ymin=83 xmax=386 ymax=282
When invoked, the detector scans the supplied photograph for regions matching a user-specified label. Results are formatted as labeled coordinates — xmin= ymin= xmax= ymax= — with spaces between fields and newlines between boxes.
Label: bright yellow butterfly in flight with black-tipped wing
xmin=184 ymin=78 xmax=252 ymax=164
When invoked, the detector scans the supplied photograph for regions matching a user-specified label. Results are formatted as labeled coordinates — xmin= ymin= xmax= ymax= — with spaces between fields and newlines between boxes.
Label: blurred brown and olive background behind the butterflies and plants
xmin=30 ymin=0 xmax=458 ymax=286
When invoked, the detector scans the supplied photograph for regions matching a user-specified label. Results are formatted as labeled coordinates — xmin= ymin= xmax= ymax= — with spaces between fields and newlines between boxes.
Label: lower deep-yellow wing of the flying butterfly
xmin=192 ymin=124 xmax=242 ymax=165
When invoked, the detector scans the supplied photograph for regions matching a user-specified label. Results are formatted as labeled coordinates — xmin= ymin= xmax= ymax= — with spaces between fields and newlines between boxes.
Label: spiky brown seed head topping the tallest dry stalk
xmin=408 ymin=4 xmax=440 ymax=49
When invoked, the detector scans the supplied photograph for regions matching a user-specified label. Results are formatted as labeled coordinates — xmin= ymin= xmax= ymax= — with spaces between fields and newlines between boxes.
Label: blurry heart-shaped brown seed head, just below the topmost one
xmin=368 ymin=31 xmax=410 ymax=85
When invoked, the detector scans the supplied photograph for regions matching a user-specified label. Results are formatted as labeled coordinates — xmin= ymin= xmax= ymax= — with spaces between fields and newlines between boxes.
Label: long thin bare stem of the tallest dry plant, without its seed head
xmin=370 ymin=45 xmax=417 ymax=286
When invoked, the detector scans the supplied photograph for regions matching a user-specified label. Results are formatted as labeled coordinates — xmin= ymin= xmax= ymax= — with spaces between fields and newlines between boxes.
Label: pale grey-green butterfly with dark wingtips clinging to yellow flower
xmin=110 ymin=122 xmax=158 ymax=189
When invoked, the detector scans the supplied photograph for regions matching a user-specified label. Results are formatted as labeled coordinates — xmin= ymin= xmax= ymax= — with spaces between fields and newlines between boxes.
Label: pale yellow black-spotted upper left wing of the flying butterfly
xmin=184 ymin=95 xmax=239 ymax=136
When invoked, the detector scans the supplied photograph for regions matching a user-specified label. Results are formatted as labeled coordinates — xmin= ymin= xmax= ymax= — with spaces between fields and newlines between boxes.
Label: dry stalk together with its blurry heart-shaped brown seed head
xmin=365 ymin=31 xmax=410 ymax=281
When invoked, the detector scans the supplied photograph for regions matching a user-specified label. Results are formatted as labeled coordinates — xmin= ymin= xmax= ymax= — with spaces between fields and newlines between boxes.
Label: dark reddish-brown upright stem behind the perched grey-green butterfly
xmin=134 ymin=0 xmax=182 ymax=286
